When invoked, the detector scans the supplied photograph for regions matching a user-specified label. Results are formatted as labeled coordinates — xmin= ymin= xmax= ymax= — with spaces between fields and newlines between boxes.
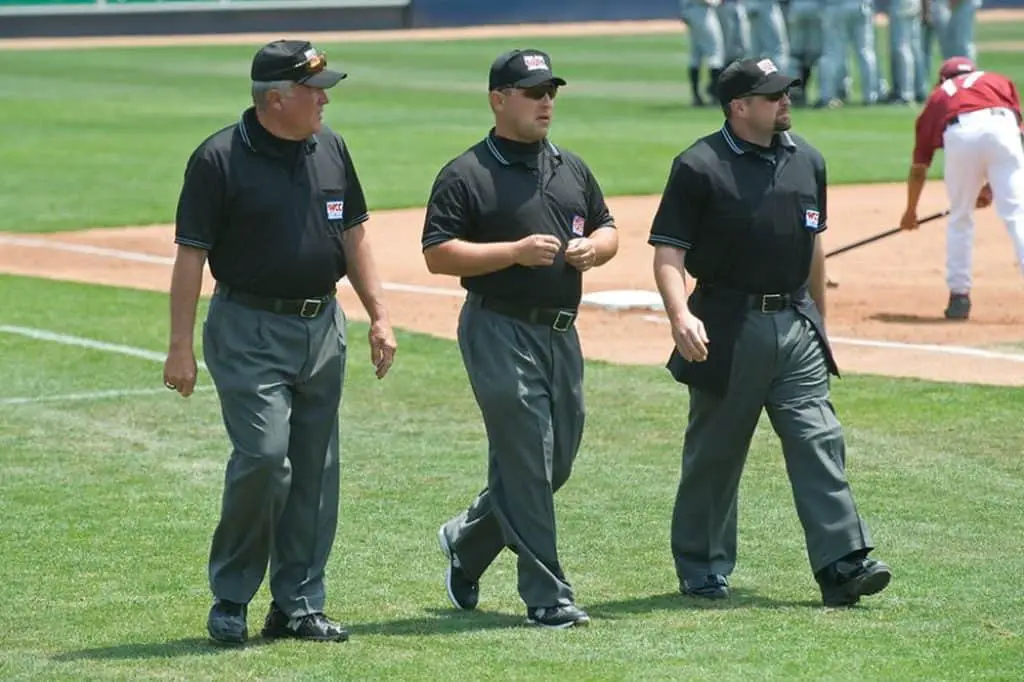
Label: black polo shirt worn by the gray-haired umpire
xmin=174 ymin=109 xmax=369 ymax=298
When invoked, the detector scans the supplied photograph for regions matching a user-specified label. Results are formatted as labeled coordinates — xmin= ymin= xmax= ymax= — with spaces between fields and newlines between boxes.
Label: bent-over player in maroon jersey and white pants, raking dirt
xmin=900 ymin=56 xmax=1024 ymax=319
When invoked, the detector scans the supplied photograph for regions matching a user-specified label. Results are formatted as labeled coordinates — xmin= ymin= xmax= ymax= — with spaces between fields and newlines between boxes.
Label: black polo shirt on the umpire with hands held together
xmin=422 ymin=129 xmax=613 ymax=308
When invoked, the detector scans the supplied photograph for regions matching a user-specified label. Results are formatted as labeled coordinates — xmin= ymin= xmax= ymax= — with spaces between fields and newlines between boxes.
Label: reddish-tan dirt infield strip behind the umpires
xmin=0 ymin=182 xmax=1024 ymax=386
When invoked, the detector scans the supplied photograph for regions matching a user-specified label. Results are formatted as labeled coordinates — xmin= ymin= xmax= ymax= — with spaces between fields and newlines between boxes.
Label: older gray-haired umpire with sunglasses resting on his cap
xmin=164 ymin=40 xmax=395 ymax=643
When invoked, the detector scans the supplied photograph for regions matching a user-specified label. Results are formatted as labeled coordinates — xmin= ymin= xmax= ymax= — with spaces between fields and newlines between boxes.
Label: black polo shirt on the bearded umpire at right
xmin=647 ymin=124 xmax=827 ymax=293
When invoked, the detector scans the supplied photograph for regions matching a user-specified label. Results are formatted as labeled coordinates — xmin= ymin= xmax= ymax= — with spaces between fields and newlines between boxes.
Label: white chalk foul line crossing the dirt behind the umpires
xmin=0 ymin=235 xmax=1024 ymax=363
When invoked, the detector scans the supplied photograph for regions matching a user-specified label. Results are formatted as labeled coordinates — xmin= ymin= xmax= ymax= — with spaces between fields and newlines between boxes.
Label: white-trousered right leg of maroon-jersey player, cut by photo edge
xmin=987 ymin=116 xmax=1024 ymax=273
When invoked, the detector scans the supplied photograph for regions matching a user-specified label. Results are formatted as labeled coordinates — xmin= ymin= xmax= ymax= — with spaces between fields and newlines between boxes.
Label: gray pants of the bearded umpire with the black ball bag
xmin=672 ymin=308 xmax=871 ymax=584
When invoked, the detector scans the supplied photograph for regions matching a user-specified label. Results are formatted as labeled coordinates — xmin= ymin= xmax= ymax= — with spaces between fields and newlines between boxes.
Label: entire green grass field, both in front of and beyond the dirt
xmin=0 ymin=24 xmax=1024 ymax=682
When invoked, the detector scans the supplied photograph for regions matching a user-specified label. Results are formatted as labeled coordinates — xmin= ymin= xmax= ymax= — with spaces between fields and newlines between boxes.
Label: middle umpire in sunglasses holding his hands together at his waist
xmin=422 ymin=49 xmax=618 ymax=628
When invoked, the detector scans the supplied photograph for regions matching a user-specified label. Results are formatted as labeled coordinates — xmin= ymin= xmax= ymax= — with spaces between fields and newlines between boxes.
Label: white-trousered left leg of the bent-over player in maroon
xmin=943 ymin=124 xmax=994 ymax=294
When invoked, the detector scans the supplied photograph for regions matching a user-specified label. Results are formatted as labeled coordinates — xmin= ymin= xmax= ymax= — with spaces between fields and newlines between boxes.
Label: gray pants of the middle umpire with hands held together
xmin=445 ymin=294 xmax=584 ymax=607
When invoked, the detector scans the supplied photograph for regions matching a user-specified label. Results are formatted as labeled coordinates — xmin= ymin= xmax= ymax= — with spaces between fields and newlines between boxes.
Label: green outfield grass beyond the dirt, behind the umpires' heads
xmin=0 ymin=23 xmax=1024 ymax=231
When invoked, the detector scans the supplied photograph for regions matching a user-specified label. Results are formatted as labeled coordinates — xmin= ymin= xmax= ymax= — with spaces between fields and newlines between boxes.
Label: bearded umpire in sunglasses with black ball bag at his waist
xmin=648 ymin=59 xmax=891 ymax=606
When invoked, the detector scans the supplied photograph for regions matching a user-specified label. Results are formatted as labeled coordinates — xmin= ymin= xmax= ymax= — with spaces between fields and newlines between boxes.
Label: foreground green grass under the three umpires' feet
xmin=0 ymin=276 xmax=1024 ymax=682
